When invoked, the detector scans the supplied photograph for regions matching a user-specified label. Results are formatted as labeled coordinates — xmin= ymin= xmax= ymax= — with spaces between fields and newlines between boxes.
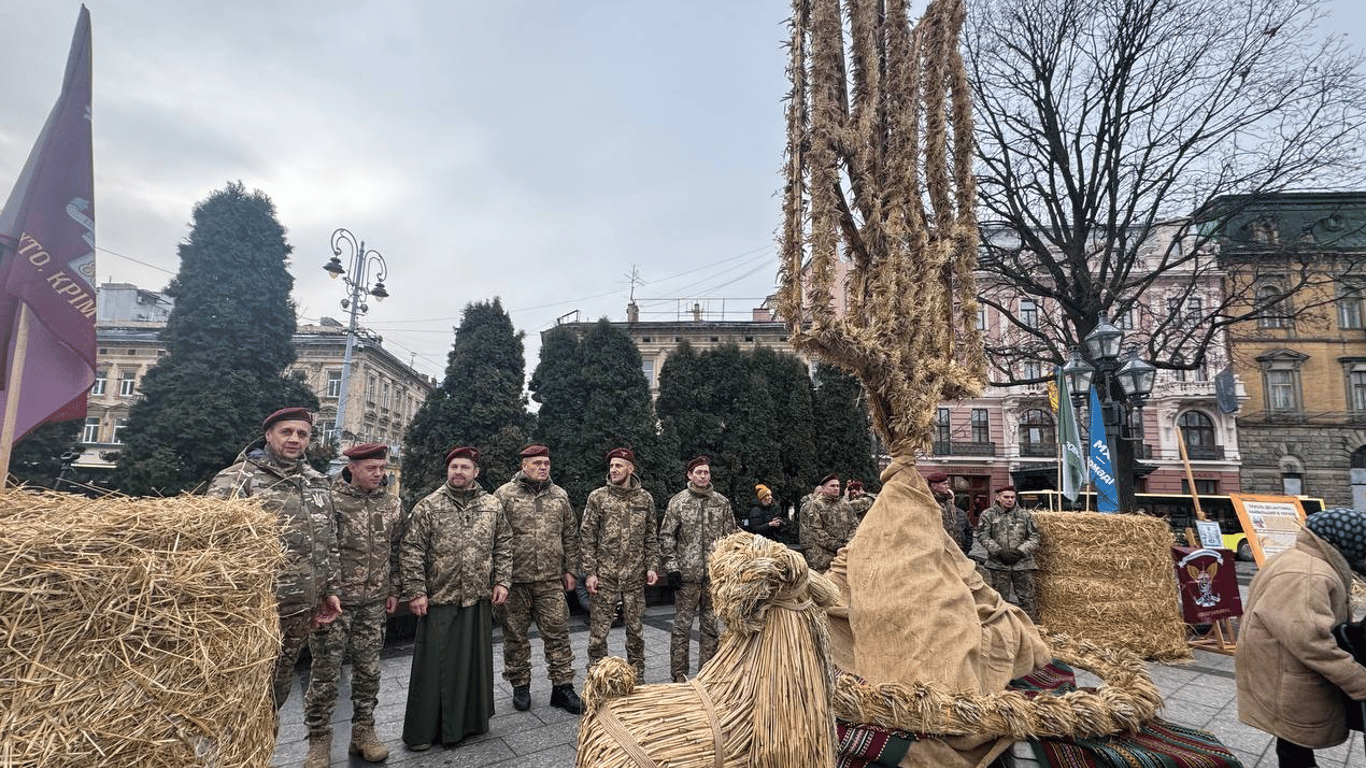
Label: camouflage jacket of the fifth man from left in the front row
xmin=579 ymin=474 xmax=660 ymax=589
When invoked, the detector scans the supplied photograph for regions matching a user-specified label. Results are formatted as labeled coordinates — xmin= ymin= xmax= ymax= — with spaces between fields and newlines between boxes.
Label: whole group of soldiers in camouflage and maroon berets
xmin=208 ymin=407 xmax=1040 ymax=768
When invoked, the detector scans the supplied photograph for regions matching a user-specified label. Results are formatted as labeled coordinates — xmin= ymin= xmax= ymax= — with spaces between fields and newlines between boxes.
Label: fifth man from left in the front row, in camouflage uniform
xmin=579 ymin=448 xmax=660 ymax=682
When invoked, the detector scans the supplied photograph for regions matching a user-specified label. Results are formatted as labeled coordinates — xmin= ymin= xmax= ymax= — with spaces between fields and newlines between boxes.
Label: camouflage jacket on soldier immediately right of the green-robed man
xmin=493 ymin=471 xmax=579 ymax=584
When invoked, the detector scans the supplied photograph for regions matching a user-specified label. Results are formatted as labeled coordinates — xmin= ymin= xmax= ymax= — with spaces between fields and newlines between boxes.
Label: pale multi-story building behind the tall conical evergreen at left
xmin=72 ymin=283 xmax=436 ymax=477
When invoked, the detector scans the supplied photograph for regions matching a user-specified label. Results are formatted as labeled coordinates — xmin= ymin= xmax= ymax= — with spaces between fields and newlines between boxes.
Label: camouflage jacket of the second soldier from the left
xmin=332 ymin=470 xmax=403 ymax=605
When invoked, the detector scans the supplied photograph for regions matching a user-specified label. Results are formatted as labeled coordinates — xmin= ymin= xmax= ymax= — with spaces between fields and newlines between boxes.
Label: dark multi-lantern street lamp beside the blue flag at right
xmin=1063 ymin=314 xmax=1157 ymax=512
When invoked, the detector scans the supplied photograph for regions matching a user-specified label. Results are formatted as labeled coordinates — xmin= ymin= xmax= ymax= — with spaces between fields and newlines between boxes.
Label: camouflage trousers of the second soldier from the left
xmin=303 ymin=600 xmax=388 ymax=734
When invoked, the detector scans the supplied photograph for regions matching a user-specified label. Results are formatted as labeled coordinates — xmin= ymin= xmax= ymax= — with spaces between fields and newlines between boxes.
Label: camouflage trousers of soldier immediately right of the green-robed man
xmin=497 ymin=581 xmax=574 ymax=686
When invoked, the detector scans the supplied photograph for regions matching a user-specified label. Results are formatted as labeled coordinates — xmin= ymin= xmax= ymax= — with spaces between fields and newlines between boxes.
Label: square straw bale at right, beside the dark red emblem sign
xmin=1034 ymin=511 xmax=1191 ymax=661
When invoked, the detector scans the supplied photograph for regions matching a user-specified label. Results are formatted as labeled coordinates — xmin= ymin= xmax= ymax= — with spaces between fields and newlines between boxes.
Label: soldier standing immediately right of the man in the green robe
xmin=493 ymin=445 xmax=583 ymax=715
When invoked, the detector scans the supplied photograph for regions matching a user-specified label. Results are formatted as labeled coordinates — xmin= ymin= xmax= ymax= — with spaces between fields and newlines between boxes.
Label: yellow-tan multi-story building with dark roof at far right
xmin=1217 ymin=193 xmax=1366 ymax=511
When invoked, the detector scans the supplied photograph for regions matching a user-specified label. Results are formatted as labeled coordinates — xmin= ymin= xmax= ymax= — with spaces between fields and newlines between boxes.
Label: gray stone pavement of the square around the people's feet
xmin=273 ymin=563 xmax=1366 ymax=768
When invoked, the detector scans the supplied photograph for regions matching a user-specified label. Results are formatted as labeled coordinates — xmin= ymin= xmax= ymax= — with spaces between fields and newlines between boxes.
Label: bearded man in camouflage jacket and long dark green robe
xmin=399 ymin=445 xmax=512 ymax=752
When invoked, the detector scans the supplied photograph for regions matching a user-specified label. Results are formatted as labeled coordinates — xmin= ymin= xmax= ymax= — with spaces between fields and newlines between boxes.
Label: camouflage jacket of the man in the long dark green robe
xmin=399 ymin=484 xmax=512 ymax=608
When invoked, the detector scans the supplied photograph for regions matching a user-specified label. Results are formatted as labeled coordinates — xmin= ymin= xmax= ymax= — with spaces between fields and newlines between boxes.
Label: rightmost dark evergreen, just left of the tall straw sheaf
xmin=809 ymin=364 xmax=878 ymax=491
